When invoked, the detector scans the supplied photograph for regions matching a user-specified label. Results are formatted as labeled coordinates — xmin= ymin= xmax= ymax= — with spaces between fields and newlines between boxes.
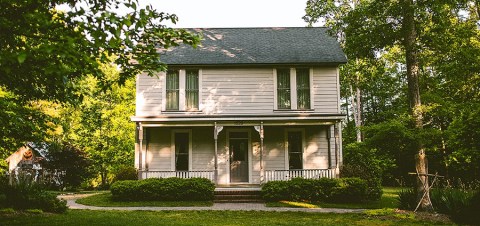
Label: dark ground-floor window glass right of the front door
xmin=287 ymin=131 xmax=303 ymax=169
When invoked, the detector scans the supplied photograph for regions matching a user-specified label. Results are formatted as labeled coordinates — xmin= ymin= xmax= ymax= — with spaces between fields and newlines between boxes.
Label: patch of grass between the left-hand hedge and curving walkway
xmin=76 ymin=192 xmax=213 ymax=207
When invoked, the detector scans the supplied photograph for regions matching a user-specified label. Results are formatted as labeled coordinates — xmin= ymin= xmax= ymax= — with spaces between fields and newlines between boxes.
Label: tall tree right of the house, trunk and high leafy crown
xmin=304 ymin=0 xmax=479 ymax=210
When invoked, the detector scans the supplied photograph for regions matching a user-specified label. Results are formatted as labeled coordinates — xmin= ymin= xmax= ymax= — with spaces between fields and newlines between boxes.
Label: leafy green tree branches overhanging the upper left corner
xmin=0 ymin=0 xmax=199 ymax=157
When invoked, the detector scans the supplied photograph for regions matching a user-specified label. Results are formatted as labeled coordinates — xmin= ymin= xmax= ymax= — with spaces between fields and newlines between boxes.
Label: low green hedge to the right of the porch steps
xmin=262 ymin=178 xmax=381 ymax=203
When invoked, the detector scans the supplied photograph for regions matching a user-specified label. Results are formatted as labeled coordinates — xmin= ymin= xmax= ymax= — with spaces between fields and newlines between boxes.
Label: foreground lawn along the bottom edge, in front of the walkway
xmin=0 ymin=210 xmax=454 ymax=226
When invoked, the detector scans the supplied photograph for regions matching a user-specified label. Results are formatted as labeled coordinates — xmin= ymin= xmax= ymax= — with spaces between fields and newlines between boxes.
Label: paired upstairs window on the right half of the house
xmin=276 ymin=68 xmax=311 ymax=110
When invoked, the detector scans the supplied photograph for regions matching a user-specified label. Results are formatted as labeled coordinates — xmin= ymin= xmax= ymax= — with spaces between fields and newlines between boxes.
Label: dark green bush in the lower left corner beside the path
xmin=0 ymin=184 xmax=67 ymax=213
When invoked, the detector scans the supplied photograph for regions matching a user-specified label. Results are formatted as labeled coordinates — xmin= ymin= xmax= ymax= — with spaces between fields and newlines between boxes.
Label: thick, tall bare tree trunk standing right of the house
xmin=403 ymin=0 xmax=433 ymax=211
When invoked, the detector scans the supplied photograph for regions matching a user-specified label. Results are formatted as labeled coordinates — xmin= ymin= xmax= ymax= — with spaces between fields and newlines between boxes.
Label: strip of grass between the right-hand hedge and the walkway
xmin=266 ymin=187 xmax=402 ymax=209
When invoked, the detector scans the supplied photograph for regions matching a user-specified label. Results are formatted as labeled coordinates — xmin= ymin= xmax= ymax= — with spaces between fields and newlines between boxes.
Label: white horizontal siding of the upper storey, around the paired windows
xmin=136 ymin=67 xmax=340 ymax=116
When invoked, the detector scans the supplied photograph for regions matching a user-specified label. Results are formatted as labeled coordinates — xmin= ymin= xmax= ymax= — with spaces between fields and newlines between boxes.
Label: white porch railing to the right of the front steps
xmin=265 ymin=169 xmax=337 ymax=182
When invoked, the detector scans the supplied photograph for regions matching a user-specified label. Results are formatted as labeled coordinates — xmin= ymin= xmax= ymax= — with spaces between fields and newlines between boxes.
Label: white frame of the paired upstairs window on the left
xmin=160 ymin=68 xmax=203 ymax=112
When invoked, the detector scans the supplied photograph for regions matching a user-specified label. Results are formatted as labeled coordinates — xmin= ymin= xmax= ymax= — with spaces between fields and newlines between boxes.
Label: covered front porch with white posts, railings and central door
xmin=135 ymin=114 xmax=342 ymax=186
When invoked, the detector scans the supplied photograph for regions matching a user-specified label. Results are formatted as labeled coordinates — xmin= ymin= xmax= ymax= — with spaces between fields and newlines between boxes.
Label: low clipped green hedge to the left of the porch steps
xmin=110 ymin=177 xmax=215 ymax=201
